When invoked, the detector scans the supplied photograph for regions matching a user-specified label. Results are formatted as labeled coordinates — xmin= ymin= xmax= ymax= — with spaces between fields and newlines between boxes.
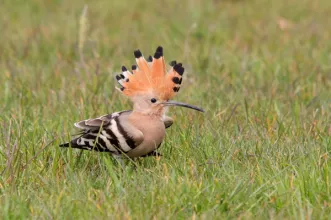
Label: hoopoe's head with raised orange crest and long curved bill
xmin=116 ymin=47 xmax=204 ymax=116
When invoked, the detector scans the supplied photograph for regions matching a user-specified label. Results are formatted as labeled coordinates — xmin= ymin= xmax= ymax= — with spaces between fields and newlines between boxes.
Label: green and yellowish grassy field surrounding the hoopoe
xmin=0 ymin=0 xmax=331 ymax=219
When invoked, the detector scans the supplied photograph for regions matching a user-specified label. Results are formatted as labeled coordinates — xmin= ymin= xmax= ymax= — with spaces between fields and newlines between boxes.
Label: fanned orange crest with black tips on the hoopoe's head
xmin=116 ymin=47 xmax=184 ymax=100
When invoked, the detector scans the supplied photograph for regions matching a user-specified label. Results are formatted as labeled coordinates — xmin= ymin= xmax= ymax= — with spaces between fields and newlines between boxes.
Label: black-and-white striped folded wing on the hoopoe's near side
xmin=60 ymin=111 xmax=144 ymax=155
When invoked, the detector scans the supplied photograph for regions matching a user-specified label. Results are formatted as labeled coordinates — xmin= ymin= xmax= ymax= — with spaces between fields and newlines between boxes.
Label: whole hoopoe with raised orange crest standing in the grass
xmin=60 ymin=47 xmax=204 ymax=158
